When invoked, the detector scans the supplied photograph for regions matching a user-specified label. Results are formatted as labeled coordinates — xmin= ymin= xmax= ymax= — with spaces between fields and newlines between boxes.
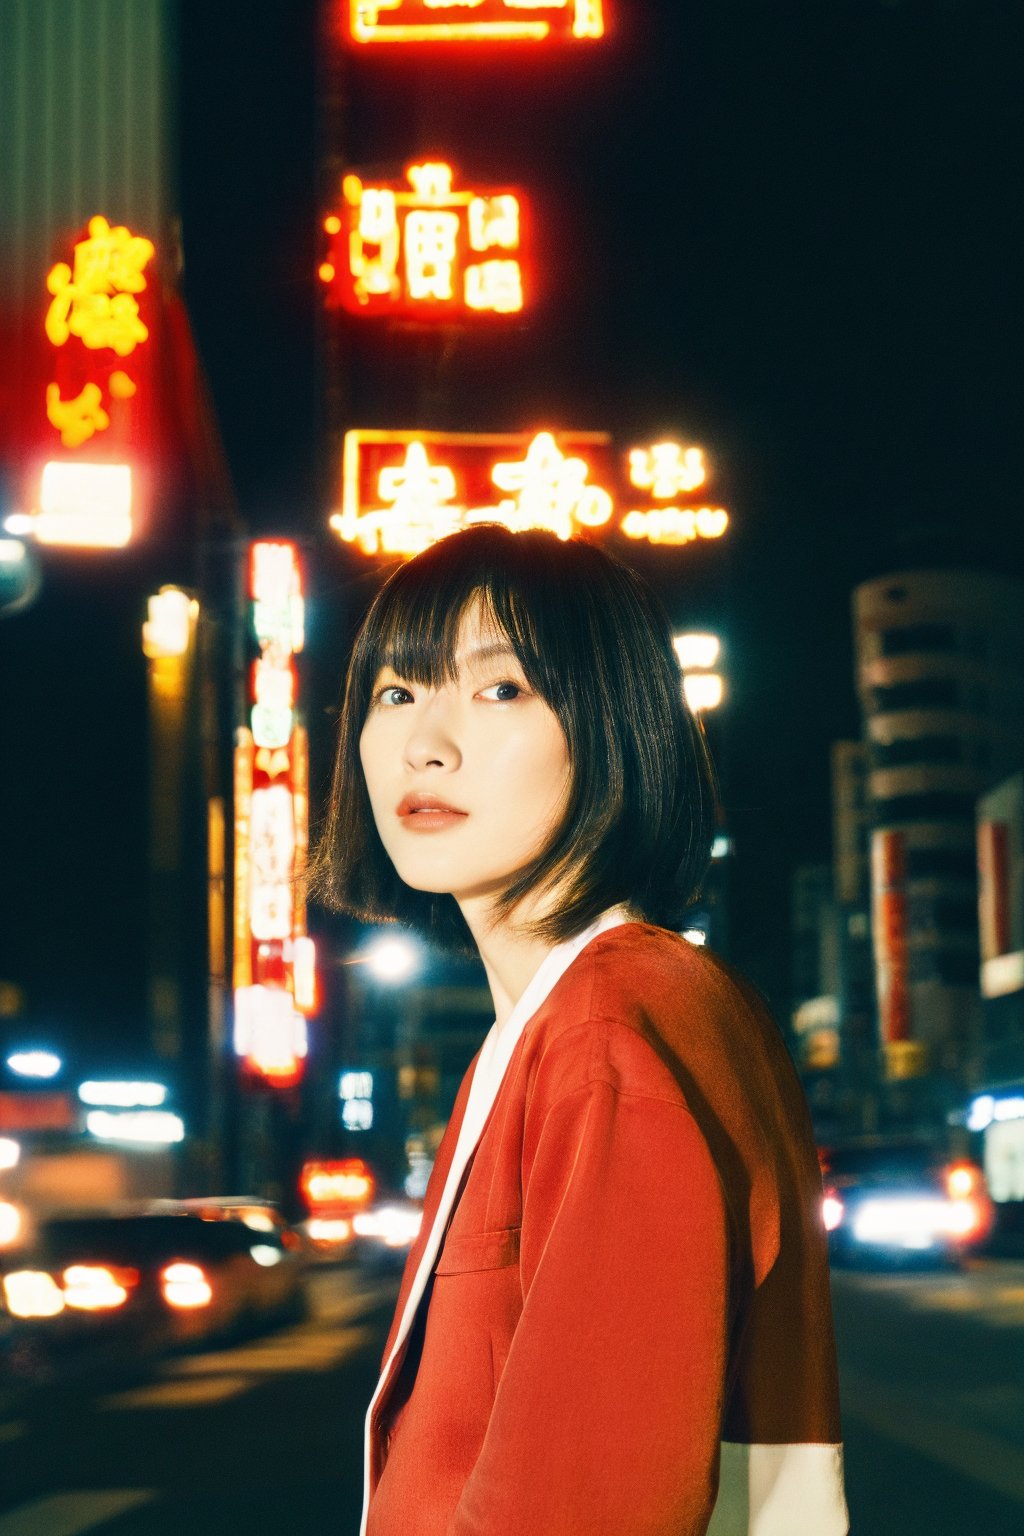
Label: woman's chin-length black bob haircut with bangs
xmin=310 ymin=524 xmax=715 ymax=951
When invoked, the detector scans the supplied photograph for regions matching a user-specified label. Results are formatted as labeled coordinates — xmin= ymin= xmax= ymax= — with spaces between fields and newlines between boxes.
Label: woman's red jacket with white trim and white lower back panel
xmin=367 ymin=923 xmax=847 ymax=1536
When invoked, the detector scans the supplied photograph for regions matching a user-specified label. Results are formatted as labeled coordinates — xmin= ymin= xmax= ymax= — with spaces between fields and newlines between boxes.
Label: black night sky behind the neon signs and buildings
xmin=0 ymin=0 xmax=1024 ymax=1056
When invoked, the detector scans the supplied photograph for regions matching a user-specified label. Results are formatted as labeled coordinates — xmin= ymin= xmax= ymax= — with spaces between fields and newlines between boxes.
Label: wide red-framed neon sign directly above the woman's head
xmin=330 ymin=432 xmax=614 ymax=554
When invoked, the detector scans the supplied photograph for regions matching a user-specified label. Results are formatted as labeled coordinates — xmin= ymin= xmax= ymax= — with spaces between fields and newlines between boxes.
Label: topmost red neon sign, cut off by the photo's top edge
xmin=341 ymin=0 xmax=605 ymax=43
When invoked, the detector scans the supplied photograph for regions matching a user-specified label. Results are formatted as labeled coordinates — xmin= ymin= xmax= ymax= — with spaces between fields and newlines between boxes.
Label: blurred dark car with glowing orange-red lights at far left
xmin=0 ymin=1213 xmax=304 ymax=1352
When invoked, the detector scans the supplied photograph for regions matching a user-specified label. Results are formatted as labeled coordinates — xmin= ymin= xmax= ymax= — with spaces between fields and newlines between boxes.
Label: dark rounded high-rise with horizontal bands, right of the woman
xmin=854 ymin=570 xmax=1024 ymax=1111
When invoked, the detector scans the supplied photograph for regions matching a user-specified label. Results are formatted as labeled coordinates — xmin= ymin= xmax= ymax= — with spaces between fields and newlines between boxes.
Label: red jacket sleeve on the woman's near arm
xmin=448 ymin=1080 xmax=728 ymax=1536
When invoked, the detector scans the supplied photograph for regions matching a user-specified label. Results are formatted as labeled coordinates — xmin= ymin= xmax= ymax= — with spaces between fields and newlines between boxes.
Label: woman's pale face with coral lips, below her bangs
xmin=359 ymin=604 xmax=570 ymax=903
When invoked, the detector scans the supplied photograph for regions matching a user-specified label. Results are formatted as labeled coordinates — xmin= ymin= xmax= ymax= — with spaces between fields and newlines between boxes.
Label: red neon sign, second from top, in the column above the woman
xmin=319 ymin=161 xmax=527 ymax=319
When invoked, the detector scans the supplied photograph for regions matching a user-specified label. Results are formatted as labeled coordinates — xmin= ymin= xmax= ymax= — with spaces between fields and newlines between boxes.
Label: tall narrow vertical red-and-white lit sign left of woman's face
xmin=233 ymin=542 xmax=316 ymax=1087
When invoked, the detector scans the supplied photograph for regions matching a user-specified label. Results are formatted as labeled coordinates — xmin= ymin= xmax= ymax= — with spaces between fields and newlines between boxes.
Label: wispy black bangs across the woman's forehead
xmin=353 ymin=530 xmax=554 ymax=708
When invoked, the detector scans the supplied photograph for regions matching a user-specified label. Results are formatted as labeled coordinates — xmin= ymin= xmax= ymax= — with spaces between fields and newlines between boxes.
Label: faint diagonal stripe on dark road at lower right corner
xmin=841 ymin=1370 xmax=1024 ymax=1499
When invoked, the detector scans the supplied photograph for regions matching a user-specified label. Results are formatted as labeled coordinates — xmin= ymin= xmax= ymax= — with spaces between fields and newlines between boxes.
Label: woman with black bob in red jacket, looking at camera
xmin=318 ymin=525 xmax=847 ymax=1536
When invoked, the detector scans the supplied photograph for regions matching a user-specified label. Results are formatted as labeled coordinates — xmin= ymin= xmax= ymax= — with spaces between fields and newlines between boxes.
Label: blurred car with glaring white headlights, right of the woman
xmin=820 ymin=1137 xmax=992 ymax=1264
